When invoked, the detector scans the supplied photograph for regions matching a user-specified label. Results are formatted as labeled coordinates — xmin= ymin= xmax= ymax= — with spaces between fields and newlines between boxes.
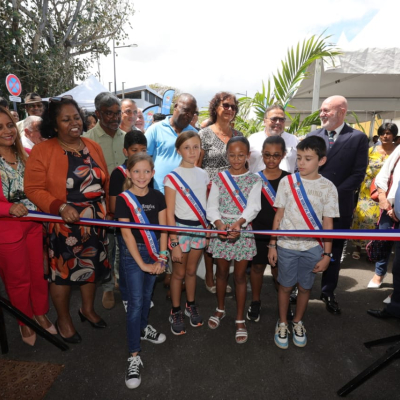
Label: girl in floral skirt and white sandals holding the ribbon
xmin=207 ymin=136 xmax=261 ymax=344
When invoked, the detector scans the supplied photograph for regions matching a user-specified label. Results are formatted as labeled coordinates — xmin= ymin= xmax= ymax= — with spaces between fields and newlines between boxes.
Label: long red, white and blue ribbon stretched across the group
xmin=0 ymin=211 xmax=400 ymax=241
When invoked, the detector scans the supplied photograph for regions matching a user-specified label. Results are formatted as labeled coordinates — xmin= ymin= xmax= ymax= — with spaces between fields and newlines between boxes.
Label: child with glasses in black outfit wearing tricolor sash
xmin=247 ymin=136 xmax=289 ymax=322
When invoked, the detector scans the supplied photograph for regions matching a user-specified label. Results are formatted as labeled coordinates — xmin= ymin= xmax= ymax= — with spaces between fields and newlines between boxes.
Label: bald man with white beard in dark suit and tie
xmin=308 ymin=96 xmax=368 ymax=314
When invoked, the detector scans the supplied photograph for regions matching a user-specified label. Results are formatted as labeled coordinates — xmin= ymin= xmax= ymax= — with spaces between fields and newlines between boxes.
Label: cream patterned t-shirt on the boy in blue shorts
xmin=274 ymin=175 xmax=339 ymax=251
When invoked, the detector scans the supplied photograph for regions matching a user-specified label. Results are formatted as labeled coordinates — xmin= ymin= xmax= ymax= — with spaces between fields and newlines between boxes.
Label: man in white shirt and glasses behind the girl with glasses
xmin=248 ymin=104 xmax=299 ymax=173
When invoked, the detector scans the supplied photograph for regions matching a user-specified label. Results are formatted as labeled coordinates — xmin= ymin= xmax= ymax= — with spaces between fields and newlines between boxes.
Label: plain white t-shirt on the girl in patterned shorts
xmin=164 ymin=167 xmax=210 ymax=225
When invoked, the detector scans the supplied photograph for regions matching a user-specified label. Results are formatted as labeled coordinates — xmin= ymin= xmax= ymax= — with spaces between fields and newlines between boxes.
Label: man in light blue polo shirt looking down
xmin=145 ymin=93 xmax=197 ymax=193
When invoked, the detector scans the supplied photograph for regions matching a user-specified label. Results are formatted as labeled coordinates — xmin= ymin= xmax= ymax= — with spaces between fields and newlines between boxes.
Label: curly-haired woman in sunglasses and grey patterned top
xmin=198 ymin=92 xmax=243 ymax=293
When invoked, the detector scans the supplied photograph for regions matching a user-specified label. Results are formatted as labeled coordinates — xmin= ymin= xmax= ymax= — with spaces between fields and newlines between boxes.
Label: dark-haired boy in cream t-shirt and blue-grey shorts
xmin=268 ymin=136 xmax=339 ymax=349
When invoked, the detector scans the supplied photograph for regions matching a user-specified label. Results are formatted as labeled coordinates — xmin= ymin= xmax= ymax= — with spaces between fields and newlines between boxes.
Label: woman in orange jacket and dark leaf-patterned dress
xmin=25 ymin=96 xmax=110 ymax=343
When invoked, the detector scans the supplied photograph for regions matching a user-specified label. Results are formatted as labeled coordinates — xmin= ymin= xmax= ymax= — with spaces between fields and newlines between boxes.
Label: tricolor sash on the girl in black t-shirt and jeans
xmin=120 ymin=190 xmax=160 ymax=261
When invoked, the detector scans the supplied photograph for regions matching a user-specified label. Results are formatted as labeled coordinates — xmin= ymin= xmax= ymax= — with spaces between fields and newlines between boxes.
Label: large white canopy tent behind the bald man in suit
xmin=289 ymin=9 xmax=400 ymax=122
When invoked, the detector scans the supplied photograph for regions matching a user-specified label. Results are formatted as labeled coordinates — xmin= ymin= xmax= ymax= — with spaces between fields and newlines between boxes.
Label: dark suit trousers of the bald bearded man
xmin=321 ymin=215 xmax=352 ymax=297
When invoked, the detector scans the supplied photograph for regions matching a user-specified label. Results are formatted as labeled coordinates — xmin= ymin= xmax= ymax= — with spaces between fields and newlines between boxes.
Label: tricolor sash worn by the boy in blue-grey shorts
xmin=288 ymin=172 xmax=324 ymax=247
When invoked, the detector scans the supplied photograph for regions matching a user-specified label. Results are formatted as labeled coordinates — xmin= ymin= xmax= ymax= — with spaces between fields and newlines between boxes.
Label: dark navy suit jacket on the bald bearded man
xmin=307 ymin=124 xmax=369 ymax=217
